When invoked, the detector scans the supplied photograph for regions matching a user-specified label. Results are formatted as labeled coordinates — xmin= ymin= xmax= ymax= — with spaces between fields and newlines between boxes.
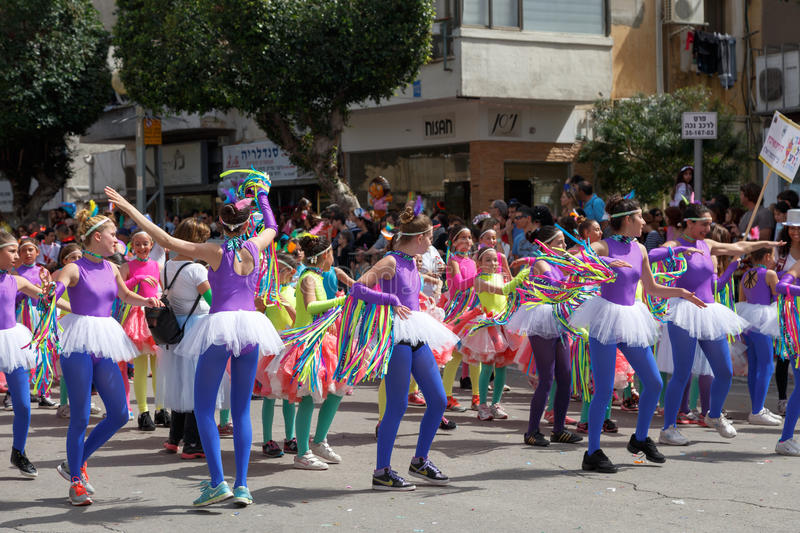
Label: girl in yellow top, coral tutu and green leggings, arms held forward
xmin=461 ymin=247 xmax=532 ymax=420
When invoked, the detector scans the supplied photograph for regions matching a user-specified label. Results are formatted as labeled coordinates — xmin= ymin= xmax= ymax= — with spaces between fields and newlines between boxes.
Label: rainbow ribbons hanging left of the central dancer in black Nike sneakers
xmin=334 ymin=296 xmax=394 ymax=385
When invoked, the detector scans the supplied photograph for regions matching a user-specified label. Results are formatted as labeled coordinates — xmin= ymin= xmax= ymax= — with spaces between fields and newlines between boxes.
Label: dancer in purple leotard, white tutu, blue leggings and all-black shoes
xmin=570 ymin=196 xmax=704 ymax=473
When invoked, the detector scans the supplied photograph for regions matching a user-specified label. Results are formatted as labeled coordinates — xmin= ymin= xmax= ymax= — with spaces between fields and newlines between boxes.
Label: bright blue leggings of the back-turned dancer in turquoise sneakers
xmin=194 ymin=344 xmax=258 ymax=487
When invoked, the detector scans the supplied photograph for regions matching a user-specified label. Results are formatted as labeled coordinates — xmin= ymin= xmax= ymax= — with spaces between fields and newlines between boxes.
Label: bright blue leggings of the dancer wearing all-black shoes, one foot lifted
xmin=588 ymin=337 xmax=664 ymax=455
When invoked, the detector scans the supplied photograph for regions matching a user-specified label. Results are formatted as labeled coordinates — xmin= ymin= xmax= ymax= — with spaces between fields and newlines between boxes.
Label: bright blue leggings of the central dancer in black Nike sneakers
xmin=376 ymin=344 xmax=447 ymax=469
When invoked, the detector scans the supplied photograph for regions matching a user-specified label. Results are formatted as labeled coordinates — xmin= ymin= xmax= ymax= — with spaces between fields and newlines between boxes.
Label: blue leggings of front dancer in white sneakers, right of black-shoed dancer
xmin=664 ymin=322 xmax=733 ymax=429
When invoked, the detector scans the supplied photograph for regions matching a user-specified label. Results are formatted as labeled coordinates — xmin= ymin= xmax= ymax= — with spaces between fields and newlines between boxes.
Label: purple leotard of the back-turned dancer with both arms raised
xmin=208 ymin=241 xmax=261 ymax=314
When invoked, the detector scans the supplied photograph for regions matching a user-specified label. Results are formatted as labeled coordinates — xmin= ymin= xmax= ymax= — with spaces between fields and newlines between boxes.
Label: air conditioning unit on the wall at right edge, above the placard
xmin=756 ymin=50 xmax=800 ymax=113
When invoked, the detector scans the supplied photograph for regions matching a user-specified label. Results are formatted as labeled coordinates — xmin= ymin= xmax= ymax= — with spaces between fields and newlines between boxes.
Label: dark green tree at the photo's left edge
xmin=0 ymin=0 xmax=111 ymax=223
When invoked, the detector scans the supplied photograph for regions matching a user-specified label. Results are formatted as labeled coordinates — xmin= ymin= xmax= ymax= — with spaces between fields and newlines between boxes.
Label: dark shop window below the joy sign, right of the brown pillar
xmin=504 ymin=162 xmax=570 ymax=214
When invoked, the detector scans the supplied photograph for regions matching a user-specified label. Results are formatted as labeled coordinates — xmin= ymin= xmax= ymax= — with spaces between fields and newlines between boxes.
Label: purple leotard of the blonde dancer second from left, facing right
xmin=67 ymin=257 xmax=117 ymax=317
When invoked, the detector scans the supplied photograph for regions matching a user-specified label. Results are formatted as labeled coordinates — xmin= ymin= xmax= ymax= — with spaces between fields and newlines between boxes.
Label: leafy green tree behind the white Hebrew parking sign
xmin=578 ymin=87 xmax=749 ymax=202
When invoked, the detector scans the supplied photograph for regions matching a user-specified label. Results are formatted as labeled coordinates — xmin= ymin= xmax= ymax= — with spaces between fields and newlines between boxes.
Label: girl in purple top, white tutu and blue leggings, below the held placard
xmin=736 ymin=248 xmax=783 ymax=426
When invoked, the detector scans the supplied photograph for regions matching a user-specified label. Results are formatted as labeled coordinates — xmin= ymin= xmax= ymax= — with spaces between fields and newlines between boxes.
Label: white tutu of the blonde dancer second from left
xmin=59 ymin=313 xmax=139 ymax=363
